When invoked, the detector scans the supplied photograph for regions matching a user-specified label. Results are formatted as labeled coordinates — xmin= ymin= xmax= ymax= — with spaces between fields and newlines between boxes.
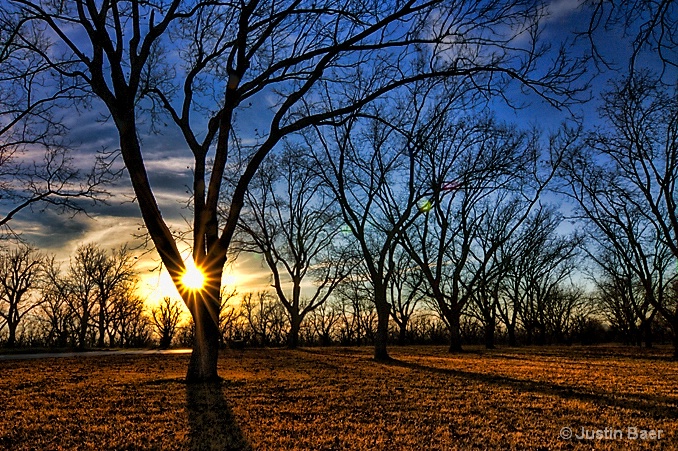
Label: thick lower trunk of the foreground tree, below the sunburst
xmin=185 ymin=286 xmax=220 ymax=382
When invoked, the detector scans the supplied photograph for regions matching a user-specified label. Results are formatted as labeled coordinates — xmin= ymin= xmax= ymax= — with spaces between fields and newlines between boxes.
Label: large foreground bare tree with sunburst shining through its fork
xmin=2 ymin=0 xmax=582 ymax=380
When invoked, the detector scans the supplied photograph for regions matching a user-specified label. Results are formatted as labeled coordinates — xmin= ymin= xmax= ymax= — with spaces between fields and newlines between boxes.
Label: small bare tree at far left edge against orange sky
xmin=0 ymin=244 xmax=45 ymax=347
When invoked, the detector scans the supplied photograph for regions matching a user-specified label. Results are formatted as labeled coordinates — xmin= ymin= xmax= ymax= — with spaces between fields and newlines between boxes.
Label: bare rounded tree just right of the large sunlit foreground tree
xmin=235 ymin=148 xmax=352 ymax=348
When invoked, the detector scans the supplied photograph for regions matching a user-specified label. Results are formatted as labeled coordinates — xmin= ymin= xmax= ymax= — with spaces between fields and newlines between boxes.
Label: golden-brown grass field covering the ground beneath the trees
xmin=0 ymin=347 xmax=678 ymax=450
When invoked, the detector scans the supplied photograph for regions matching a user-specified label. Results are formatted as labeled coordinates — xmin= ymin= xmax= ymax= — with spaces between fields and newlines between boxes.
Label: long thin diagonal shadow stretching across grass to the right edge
xmin=380 ymin=359 xmax=678 ymax=419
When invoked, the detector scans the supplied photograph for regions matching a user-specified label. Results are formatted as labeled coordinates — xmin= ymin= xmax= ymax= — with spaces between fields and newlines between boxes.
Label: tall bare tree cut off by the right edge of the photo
xmin=563 ymin=73 xmax=678 ymax=357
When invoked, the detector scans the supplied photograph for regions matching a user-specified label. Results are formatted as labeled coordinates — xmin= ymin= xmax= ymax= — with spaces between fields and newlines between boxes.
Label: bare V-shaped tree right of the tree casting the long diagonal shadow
xmin=402 ymin=111 xmax=567 ymax=352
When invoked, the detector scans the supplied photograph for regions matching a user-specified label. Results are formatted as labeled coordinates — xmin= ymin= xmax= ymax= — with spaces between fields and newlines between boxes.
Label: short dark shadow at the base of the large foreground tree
xmin=186 ymin=382 xmax=252 ymax=451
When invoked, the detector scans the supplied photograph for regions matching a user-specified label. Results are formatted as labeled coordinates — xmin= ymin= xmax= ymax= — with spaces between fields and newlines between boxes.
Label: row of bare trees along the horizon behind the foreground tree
xmin=0 ymin=73 xmax=678 ymax=351
